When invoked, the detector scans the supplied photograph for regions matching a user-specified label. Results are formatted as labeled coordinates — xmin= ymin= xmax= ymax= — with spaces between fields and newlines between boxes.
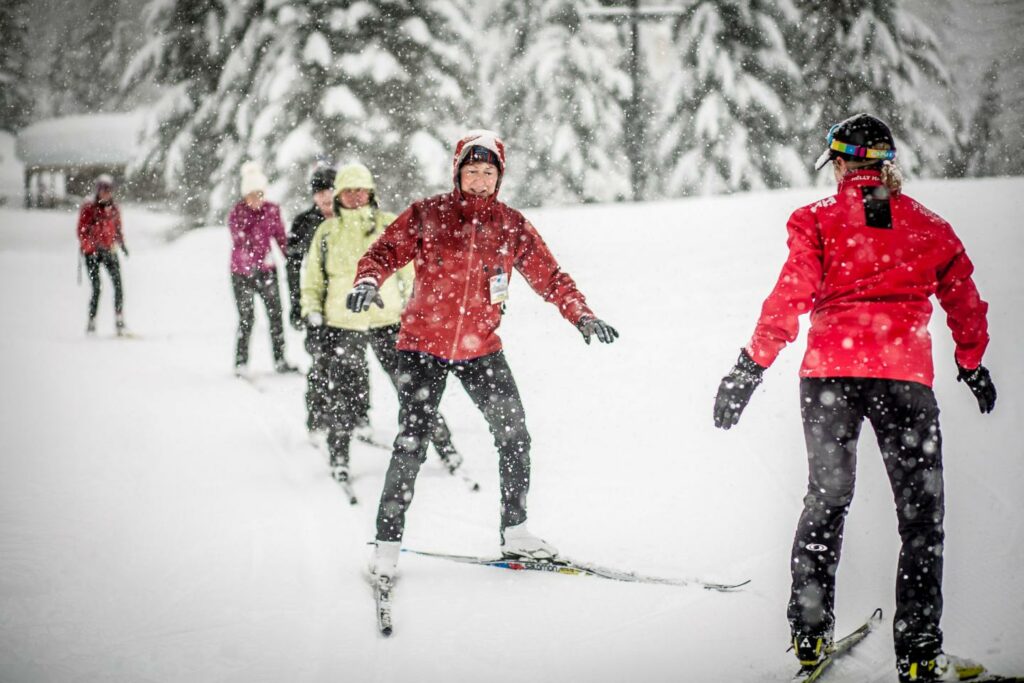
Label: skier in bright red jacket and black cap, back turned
xmin=714 ymin=114 xmax=995 ymax=681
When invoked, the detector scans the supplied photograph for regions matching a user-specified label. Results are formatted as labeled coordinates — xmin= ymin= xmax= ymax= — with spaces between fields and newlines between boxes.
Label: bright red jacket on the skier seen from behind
xmin=746 ymin=170 xmax=988 ymax=386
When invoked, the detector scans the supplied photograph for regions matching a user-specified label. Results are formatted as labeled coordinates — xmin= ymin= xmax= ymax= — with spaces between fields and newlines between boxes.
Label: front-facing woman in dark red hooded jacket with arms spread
xmin=347 ymin=130 xmax=618 ymax=578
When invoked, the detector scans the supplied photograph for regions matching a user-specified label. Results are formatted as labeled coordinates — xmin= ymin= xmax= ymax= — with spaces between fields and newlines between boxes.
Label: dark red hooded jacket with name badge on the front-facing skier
xmin=355 ymin=189 xmax=593 ymax=360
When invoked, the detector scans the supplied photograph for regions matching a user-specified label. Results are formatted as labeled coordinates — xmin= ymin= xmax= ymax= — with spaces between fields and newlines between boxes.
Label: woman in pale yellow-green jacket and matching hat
xmin=301 ymin=163 xmax=462 ymax=481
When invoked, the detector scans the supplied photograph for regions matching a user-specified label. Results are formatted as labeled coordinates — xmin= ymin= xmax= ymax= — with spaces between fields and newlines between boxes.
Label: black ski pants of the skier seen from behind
xmin=788 ymin=378 xmax=945 ymax=658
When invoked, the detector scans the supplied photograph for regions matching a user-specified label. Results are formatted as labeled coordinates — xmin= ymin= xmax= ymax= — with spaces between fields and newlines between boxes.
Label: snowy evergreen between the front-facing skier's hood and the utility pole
xmin=480 ymin=0 xmax=631 ymax=205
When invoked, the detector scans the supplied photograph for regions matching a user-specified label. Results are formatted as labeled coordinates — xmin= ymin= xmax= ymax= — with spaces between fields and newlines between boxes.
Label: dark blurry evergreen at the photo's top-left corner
xmin=0 ymin=0 xmax=32 ymax=132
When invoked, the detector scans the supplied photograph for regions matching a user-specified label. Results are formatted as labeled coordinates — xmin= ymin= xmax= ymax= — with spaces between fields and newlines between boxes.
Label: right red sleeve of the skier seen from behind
xmin=935 ymin=240 xmax=988 ymax=370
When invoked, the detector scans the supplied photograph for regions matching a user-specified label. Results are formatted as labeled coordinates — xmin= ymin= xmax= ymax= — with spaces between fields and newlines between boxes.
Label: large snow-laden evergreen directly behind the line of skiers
xmin=214 ymin=0 xmax=469 ymax=220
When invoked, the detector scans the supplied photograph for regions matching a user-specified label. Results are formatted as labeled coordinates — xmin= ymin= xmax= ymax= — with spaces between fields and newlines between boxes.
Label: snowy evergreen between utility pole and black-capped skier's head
xmin=657 ymin=0 xmax=807 ymax=197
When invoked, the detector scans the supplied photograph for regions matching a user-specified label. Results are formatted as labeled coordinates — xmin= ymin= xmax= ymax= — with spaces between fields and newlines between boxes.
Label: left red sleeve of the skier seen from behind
xmin=746 ymin=209 xmax=823 ymax=368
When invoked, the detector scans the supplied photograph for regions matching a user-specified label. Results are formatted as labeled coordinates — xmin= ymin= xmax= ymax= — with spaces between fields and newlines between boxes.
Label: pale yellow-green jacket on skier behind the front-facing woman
xmin=302 ymin=205 xmax=414 ymax=330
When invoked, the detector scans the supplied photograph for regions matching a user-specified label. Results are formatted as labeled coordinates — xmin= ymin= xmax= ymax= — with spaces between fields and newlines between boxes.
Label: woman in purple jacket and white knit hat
xmin=227 ymin=162 xmax=296 ymax=377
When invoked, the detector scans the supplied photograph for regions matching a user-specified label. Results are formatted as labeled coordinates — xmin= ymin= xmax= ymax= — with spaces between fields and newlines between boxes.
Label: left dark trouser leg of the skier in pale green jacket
xmin=315 ymin=326 xmax=369 ymax=465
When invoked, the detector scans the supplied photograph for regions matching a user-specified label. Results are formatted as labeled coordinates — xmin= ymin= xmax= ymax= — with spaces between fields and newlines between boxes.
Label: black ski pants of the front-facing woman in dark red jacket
xmin=377 ymin=351 xmax=529 ymax=541
